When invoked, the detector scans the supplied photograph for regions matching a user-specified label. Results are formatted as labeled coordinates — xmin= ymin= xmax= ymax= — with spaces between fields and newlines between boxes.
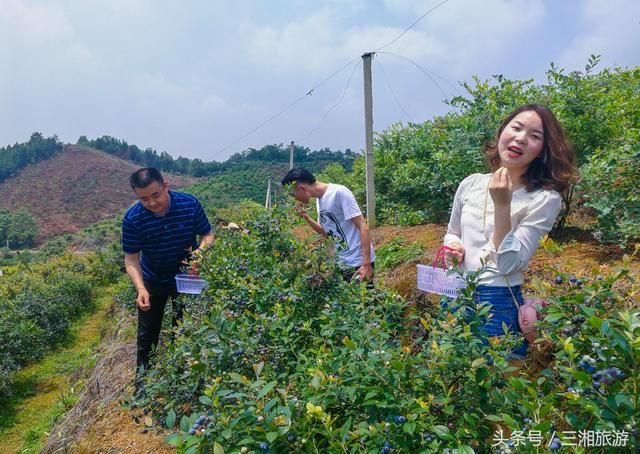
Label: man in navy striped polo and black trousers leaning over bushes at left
xmin=122 ymin=168 xmax=213 ymax=393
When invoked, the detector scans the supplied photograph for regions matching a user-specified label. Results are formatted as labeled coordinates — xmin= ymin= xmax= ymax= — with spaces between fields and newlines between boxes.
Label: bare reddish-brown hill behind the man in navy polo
xmin=0 ymin=145 xmax=195 ymax=241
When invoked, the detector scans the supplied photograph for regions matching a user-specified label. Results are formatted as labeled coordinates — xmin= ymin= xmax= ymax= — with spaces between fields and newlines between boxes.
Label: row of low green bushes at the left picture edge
xmin=0 ymin=250 xmax=121 ymax=395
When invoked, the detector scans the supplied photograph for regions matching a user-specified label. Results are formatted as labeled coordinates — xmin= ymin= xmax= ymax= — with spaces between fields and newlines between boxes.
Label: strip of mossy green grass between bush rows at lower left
xmin=0 ymin=289 xmax=111 ymax=453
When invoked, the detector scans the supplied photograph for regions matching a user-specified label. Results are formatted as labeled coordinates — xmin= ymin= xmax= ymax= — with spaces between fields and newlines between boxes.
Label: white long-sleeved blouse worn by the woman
xmin=444 ymin=173 xmax=562 ymax=287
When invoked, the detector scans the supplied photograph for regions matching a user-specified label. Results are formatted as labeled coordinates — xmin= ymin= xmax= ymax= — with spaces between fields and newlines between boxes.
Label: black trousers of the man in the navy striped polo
xmin=136 ymin=281 xmax=182 ymax=377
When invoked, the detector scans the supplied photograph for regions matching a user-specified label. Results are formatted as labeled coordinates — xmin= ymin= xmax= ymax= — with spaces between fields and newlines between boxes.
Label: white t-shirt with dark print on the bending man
xmin=317 ymin=183 xmax=376 ymax=267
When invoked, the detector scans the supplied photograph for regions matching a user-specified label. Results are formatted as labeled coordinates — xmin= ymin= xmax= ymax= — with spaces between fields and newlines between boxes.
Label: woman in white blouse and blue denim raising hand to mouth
xmin=444 ymin=104 xmax=576 ymax=359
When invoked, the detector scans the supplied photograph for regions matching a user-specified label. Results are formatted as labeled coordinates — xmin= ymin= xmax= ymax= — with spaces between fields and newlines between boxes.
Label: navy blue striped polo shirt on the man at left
xmin=122 ymin=191 xmax=211 ymax=284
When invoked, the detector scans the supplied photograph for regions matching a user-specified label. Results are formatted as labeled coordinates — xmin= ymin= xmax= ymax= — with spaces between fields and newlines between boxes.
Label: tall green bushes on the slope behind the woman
xmin=323 ymin=56 xmax=640 ymax=245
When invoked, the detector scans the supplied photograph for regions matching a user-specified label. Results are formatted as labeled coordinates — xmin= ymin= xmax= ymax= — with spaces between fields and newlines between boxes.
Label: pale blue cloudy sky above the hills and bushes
xmin=0 ymin=0 xmax=640 ymax=161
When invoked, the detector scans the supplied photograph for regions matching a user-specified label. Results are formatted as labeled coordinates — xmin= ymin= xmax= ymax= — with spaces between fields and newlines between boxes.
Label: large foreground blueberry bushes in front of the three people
xmin=134 ymin=213 xmax=640 ymax=453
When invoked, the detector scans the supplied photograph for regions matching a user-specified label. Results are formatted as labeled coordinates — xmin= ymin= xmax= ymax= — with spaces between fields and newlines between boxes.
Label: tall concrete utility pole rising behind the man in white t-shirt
xmin=362 ymin=52 xmax=376 ymax=227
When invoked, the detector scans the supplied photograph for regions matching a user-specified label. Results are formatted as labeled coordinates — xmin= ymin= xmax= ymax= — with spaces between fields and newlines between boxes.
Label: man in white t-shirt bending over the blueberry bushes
xmin=282 ymin=167 xmax=375 ymax=281
